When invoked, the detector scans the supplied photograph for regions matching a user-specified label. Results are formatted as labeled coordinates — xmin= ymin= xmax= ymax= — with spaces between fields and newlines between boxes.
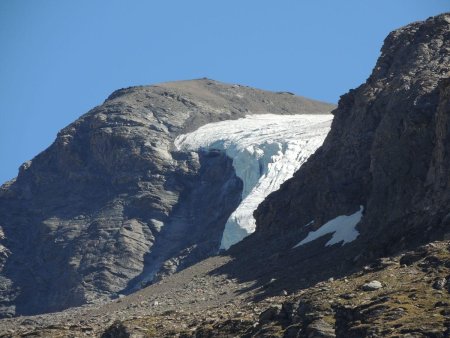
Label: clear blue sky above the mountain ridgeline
xmin=0 ymin=0 xmax=450 ymax=184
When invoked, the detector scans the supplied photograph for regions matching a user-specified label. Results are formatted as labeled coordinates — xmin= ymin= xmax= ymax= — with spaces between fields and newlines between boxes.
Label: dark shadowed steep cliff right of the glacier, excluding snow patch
xmin=253 ymin=14 xmax=450 ymax=258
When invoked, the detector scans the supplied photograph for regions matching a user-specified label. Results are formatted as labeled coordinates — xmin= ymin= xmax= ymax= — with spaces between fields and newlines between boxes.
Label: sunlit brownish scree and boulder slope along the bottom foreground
xmin=0 ymin=241 xmax=450 ymax=338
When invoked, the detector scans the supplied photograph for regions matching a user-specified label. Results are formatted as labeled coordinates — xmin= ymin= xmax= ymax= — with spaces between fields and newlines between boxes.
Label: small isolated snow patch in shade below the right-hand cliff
xmin=293 ymin=205 xmax=364 ymax=248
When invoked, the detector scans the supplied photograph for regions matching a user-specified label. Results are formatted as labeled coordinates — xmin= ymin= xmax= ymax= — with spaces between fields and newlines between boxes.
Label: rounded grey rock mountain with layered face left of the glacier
xmin=0 ymin=79 xmax=332 ymax=316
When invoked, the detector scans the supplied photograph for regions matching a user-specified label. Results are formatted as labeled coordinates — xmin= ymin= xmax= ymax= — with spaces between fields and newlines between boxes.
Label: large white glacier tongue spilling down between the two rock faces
xmin=174 ymin=114 xmax=333 ymax=250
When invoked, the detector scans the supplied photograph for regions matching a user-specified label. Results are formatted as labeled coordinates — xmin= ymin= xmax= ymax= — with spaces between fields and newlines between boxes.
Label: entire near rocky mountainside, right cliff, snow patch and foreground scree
xmin=0 ymin=14 xmax=450 ymax=338
